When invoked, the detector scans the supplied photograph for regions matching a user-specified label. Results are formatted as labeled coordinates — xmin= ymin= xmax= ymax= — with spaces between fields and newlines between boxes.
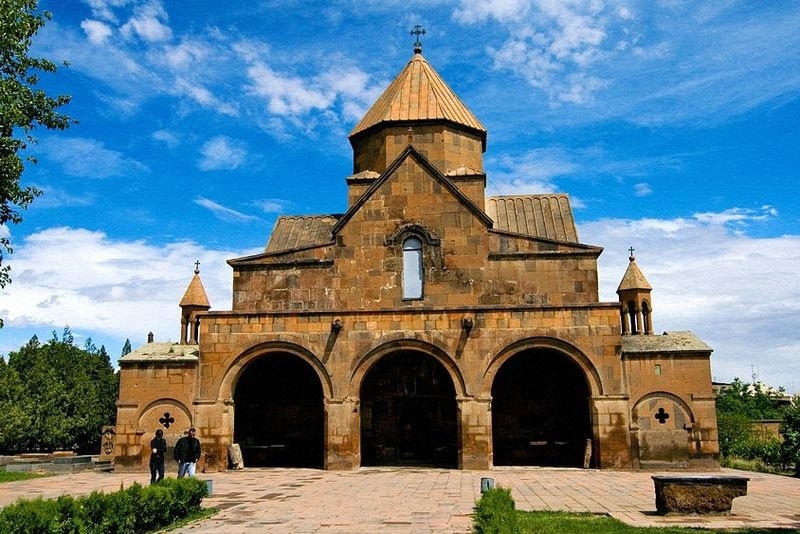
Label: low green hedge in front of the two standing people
xmin=0 ymin=478 xmax=208 ymax=534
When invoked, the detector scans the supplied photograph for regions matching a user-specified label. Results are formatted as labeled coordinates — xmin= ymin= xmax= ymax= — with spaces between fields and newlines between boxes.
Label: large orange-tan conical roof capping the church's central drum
xmin=350 ymin=54 xmax=486 ymax=137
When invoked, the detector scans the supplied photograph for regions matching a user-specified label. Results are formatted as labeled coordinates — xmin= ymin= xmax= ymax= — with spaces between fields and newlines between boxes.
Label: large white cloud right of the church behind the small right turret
xmin=578 ymin=209 xmax=800 ymax=396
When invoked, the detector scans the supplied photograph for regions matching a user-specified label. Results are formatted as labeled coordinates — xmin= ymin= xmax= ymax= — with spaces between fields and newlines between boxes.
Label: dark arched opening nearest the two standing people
xmin=233 ymin=353 xmax=325 ymax=468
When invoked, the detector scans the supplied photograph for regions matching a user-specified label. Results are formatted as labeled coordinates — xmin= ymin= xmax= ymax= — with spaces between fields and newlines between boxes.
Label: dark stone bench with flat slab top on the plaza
xmin=652 ymin=475 xmax=750 ymax=515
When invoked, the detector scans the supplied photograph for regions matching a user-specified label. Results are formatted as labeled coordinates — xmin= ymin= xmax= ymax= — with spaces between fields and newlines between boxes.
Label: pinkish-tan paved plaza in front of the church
xmin=0 ymin=468 xmax=800 ymax=534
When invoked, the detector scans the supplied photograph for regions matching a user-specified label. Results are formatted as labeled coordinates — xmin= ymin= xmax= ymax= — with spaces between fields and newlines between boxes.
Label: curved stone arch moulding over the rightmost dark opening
xmin=480 ymin=337 xmax=603 ymax=398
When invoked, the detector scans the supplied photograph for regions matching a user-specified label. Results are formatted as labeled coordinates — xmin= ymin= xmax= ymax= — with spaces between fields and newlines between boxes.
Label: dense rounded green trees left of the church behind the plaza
xmin=0 ymin=327 xmax=118 ymax=452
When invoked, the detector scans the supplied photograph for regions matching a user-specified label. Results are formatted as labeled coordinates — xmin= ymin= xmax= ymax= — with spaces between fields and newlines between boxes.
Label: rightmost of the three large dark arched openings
xmin=492 ymin=349 xmax=592 ymax=467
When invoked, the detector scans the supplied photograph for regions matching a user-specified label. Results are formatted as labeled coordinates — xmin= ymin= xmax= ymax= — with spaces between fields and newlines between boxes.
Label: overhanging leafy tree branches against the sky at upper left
xmin=0 ymin=0 xmax=73 ymax=300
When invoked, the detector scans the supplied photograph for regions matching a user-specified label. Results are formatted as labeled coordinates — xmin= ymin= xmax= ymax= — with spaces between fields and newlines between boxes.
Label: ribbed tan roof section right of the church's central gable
xmin=486 ymin=193 xmax=578 ymax=243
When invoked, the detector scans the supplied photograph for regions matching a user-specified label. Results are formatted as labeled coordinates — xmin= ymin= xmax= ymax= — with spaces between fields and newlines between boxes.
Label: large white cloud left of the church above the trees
xmin=0 ymin=228 xmax=255 ymax=362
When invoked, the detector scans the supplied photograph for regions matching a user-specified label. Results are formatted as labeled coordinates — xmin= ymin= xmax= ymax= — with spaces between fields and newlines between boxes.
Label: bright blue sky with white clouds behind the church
xmin=0 ymin=0 xmax=800 ymax=392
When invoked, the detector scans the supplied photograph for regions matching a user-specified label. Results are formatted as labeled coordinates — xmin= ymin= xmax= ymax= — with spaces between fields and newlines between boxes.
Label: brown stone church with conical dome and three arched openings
xmin=113 ymin=38 xmax=719 ymax=472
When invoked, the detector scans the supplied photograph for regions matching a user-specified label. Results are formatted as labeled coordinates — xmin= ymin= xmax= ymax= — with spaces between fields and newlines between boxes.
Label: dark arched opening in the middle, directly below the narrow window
xmin=361 ymin=352 xmax=458 ymax=467
